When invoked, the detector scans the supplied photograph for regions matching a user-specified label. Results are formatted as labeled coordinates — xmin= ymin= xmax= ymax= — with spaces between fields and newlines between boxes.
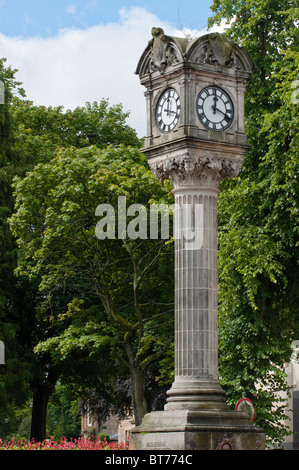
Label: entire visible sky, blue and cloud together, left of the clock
xmin=0 ymin=0 xmax=223 ymax=136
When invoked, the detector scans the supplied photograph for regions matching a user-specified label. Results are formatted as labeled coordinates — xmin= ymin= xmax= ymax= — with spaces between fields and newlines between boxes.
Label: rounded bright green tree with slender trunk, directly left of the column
xmin=11 ymin=145 xmax=173 ymax=430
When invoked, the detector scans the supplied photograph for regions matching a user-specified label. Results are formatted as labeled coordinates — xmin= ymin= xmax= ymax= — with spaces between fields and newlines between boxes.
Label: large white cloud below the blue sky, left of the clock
xmin=0 ymin=8 xmax=224 ymax=136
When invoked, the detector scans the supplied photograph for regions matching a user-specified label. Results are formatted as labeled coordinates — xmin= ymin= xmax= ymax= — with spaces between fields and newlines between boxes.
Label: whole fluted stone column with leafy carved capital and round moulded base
xmin=151 ymin=150 xmax=241 ymax=410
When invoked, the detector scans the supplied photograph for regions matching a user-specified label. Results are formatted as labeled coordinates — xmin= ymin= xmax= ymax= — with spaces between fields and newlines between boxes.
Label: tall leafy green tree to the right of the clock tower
xmin=210 ymin=0 xmax=299 ymax=442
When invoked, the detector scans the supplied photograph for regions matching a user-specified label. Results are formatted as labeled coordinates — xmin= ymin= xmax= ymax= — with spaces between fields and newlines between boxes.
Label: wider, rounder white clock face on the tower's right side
xmin=196 ymin=85 xmax=234 ymax=132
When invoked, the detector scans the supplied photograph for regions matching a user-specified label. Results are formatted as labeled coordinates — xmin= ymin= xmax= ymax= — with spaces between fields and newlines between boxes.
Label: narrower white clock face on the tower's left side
xmin=156 ymin=88 xmax=181 ymax=133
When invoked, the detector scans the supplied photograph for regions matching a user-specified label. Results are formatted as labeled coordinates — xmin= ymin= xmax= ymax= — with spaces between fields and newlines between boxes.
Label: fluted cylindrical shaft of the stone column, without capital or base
xmin=174 ymin=189 xmax=218 ymax=379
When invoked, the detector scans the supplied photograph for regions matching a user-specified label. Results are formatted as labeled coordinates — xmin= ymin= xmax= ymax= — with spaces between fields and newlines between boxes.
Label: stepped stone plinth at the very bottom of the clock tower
xmin=130 ymin=410 xmax=265 ymax=451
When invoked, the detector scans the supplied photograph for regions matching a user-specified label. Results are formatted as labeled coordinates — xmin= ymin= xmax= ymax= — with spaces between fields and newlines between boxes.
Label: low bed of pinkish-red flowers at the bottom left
xmin=0 ymin=437 xmax=129 ymax=450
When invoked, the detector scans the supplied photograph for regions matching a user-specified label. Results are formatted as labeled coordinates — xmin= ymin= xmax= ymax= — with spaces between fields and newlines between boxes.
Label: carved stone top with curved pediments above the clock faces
xmin=136 ymin=28 xmax=254 ymax=78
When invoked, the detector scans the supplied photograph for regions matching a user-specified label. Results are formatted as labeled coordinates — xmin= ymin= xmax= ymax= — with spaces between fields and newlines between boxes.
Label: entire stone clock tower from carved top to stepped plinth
xmin=130 ymin=28 xmax=264 ymax=450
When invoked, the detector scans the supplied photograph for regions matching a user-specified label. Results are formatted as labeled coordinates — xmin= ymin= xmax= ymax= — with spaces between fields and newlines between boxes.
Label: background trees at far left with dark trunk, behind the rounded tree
xmin=0 ymin=70 xmax=148 ymax=440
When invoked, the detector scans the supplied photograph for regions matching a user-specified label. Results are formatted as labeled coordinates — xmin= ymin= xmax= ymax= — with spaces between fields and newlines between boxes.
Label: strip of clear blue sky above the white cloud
xmin=0 ymin=0 xmax=213 ymax=37
